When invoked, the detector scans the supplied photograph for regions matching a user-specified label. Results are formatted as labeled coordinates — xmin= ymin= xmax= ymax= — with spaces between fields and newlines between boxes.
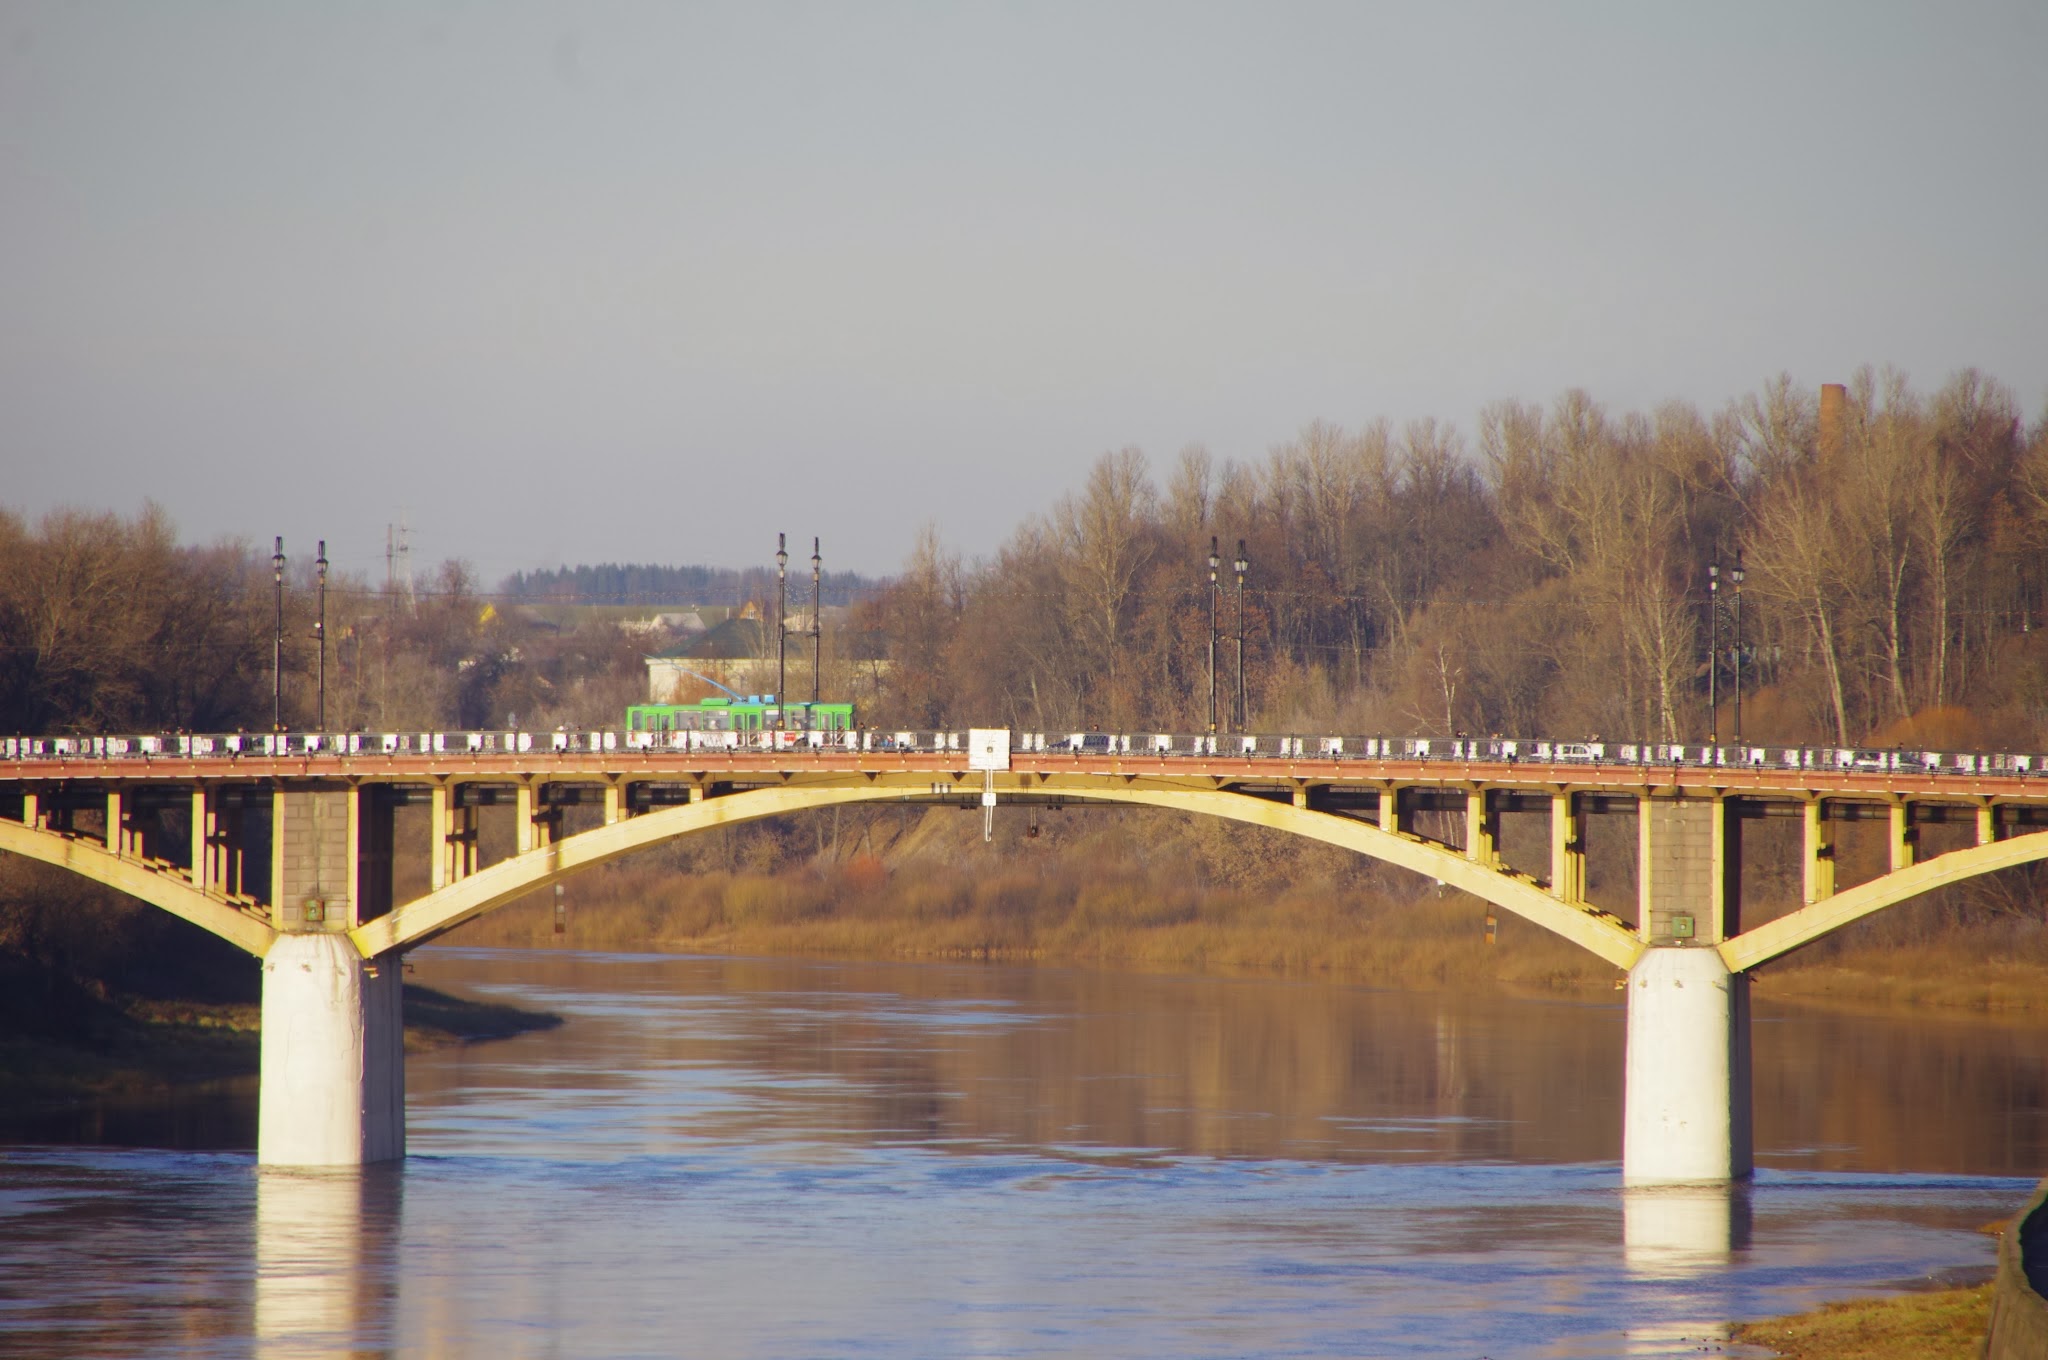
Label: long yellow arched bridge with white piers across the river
xmin=0 ymin=729 xmax=2048 ymax=1184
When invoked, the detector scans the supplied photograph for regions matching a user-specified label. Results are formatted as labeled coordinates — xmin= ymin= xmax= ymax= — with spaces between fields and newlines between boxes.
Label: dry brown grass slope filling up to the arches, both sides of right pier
xmin=440 ymin=809 xmax=2048 ymax=1014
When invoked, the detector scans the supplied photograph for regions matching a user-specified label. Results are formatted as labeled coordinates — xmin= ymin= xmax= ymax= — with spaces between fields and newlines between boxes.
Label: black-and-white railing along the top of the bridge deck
xmin=0 ymin=727 xmax=2048 ymax=778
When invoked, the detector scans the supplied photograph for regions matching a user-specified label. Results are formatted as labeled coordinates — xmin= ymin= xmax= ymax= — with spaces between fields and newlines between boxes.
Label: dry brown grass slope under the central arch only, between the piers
xmin=453 ymin=813 xmax=1614 ymax=987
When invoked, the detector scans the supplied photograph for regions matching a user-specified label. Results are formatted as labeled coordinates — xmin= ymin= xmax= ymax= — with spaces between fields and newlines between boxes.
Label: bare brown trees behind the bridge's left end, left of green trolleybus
xmin=0 ymin=508 xmax=645 ymax=733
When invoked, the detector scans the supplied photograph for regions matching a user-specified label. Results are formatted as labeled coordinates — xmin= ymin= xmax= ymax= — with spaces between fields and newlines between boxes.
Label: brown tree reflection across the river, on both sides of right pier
xmin=410 ymin=950 xmax=2048 ymax=1176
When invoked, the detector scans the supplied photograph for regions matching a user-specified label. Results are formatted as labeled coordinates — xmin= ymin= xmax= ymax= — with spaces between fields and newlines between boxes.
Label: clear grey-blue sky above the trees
xmin=0 ymin=0 xmax=2048 ymax=582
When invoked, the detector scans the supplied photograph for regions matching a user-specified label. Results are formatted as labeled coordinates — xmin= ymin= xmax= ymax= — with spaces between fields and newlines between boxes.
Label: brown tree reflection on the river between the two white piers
xmin=408 ymin=952 xmax=1622 ymax=1161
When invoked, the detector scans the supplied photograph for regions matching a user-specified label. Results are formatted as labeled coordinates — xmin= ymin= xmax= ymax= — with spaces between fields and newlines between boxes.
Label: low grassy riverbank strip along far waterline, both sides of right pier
xmin=451 ymin=854 xmax=2048 ymax=1016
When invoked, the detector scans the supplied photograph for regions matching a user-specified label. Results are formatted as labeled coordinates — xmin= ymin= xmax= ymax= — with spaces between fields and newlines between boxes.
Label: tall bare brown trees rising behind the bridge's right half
xmin=864 ymin=371 xmax=2048 ymax=746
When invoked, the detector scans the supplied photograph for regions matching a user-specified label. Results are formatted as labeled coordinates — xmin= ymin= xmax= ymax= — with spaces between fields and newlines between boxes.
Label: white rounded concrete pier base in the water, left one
xmin=256 ymin=934 xmax=406 ymax=1165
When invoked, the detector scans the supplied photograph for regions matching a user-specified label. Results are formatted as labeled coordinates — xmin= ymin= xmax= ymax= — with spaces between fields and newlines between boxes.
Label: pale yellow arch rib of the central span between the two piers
xmin=350 ymin=778 xmax=1642 ymax=971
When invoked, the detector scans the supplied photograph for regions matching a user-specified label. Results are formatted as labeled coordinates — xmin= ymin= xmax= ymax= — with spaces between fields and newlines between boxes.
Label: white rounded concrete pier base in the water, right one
xmin=1622 ymin=946 xmax=1751 ymax=1186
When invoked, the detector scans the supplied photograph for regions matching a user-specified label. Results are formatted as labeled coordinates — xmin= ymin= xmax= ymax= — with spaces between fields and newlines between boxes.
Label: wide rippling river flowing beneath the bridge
xmin=0 ymin=948 xmax=2048 ymax=1360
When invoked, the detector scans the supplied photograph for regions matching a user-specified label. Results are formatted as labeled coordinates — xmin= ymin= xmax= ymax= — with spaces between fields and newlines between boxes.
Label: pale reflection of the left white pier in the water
xmin=254 ymin=1167 xmax=401 ymax=1360
